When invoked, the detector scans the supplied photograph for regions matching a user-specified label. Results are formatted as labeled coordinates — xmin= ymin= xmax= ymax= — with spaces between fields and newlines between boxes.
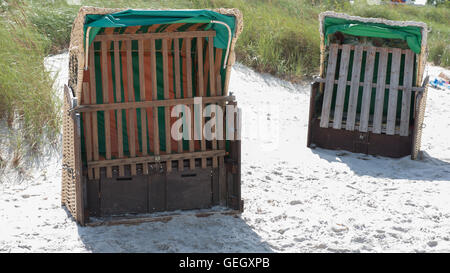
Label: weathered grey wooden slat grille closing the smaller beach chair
xmin=320 ymin=44 xmax=418 ymax=136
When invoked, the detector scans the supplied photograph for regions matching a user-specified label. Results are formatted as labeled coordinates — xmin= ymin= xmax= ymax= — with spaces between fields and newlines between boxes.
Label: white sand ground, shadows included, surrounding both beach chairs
xmin=0 ymin=54 xmax=450 ymax=252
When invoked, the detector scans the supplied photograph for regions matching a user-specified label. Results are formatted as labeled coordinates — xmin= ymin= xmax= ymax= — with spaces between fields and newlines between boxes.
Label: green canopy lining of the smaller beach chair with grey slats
xmin=323 ymin=17 xmax=422 ymax=54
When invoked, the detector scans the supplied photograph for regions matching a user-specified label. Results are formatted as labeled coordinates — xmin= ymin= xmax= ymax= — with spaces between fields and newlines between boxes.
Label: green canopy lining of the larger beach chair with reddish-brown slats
xmin=84 ymin=9 xmax=235 ymax=48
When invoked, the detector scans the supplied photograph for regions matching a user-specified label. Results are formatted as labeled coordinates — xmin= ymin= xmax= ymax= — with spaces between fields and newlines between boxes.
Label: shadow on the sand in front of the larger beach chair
xmin=73 ymin=210 xmax=272 ymax=252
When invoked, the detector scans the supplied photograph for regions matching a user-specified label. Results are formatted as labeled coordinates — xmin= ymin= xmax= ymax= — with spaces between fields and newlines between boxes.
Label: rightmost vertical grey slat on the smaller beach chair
xmin=400 ymin=50 xmax=414 ymax=136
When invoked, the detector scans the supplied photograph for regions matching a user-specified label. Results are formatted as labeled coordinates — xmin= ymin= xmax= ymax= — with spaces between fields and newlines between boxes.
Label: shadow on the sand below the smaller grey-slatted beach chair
xmin=312 ymin=148 xmax=450 ymax=181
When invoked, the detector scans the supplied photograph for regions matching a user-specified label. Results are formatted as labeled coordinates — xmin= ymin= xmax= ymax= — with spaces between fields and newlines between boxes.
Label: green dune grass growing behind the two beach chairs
xmin=22 ymin=0 xmax=450 ymax=78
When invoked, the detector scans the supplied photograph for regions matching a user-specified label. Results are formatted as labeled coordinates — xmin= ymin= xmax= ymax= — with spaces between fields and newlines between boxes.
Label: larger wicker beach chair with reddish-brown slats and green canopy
xmin=62 ymin=7 xmax=243 ymax=225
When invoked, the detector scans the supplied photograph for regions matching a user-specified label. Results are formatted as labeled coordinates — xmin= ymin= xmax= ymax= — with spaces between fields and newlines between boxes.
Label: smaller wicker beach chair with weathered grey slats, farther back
xmin=307 ymin=12 xmax=427 ymax=159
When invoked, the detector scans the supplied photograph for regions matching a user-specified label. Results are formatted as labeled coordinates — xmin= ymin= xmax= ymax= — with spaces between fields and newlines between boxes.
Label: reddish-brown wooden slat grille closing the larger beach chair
xmin=81 ymin=31 xmax=226 ymax=174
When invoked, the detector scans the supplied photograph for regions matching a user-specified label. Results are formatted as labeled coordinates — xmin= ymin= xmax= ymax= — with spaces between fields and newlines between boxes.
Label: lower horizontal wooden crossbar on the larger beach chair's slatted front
xmin=87 ymin=150 xmax=226 ymax=168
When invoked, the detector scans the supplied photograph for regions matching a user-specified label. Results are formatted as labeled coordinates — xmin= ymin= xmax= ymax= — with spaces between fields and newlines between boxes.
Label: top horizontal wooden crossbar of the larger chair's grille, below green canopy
xmin=94 ymin=30 xmax=216 ymax=42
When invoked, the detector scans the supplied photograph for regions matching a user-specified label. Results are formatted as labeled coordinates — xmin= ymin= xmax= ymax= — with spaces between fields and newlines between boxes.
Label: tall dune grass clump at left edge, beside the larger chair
xmin=0 ymin=1 xmax=60 ymax=162
